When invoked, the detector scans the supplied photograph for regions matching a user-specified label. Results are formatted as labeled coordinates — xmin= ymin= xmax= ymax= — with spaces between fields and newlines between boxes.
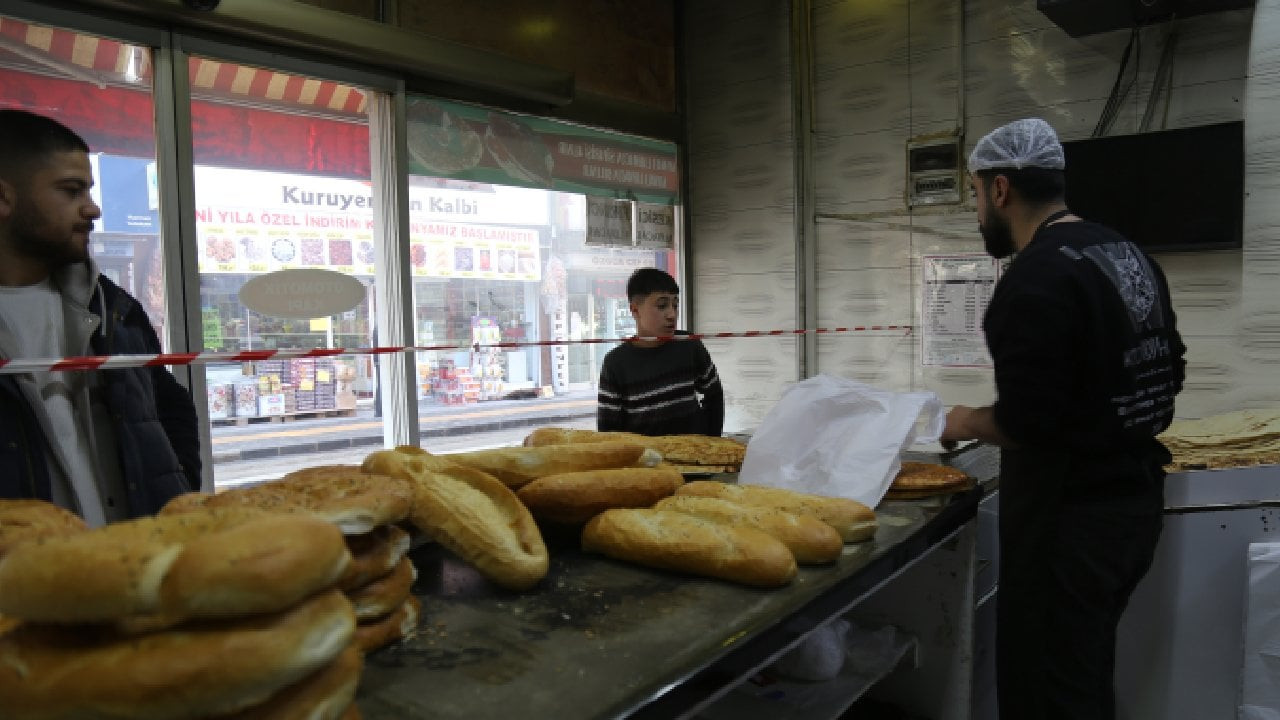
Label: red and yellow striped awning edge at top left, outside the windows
xmin=0 ymin=18 xmax=367 ymax=117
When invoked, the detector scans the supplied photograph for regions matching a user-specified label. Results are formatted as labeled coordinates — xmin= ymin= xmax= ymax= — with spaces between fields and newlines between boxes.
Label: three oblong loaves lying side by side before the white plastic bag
xmin=582 ymin=480 xmax=877 ymax=587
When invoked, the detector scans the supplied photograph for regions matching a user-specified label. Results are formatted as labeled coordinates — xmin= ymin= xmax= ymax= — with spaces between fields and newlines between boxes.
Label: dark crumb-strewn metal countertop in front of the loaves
xmin=356 ymin=491 xmax=980 ymax=720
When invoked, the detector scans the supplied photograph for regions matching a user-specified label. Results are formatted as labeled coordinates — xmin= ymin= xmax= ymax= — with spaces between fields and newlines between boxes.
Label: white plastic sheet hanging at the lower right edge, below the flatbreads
xmin=1239 ymin=542 xmax=1280 ymax=720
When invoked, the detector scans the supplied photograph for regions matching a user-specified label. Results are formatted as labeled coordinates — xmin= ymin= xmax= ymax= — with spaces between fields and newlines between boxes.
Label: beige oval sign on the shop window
xmin=239 ymin=268 xmax=365 ymax=318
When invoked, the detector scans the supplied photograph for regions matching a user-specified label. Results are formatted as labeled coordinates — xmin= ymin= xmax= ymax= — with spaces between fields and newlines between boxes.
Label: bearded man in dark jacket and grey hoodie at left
xmin=0 ymin=110 xmax=201 ymax=525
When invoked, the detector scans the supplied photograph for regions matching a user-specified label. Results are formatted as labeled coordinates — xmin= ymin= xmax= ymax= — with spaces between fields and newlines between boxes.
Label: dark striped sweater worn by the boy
xmin=596 ymin=340 xmax=724 ymax=437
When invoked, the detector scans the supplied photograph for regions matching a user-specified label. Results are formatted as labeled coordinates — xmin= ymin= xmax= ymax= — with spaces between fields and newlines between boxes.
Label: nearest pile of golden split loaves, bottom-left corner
xmin=0 ymin=501 xmax=362 ymax=720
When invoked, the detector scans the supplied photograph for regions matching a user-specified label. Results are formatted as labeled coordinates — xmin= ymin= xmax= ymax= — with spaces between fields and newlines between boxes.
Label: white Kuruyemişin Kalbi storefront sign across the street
xmin=196 ymin=168 xmax=549 ymax=282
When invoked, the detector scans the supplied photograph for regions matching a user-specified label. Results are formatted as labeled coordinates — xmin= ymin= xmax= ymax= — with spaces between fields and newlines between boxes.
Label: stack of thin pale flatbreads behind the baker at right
xmin=1158 ymin=410 xmax=1280 ymax=470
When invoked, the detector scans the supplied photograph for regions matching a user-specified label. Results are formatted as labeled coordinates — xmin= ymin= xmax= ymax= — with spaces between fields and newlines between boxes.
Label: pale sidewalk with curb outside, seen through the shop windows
xmin=211 ymin=391 xmax=596 ymax=464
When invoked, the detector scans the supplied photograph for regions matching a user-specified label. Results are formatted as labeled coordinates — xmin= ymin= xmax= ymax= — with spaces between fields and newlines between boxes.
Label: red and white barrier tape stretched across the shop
xmin=0 ymin=325 xmax=911 ymax=375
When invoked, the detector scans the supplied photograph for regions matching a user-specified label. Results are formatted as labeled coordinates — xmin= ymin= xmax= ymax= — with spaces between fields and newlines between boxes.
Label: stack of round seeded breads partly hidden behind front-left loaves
xmin=161 ymin=465 xmax=421 ymax=652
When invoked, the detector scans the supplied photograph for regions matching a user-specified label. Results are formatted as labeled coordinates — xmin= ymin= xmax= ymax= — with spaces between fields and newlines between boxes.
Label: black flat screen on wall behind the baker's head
xmin=1062 ymin=122 xmax=1244 ymax=251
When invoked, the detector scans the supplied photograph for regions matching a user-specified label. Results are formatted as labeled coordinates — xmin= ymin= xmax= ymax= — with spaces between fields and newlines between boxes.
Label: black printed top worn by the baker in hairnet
xmin=983 ymin=222 xmax=1187 ymax=464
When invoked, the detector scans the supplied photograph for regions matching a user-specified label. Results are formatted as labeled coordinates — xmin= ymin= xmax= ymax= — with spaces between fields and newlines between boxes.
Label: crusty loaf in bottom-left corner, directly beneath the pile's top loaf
xmin=0 ymin=586 xmax=356 ymax=720
